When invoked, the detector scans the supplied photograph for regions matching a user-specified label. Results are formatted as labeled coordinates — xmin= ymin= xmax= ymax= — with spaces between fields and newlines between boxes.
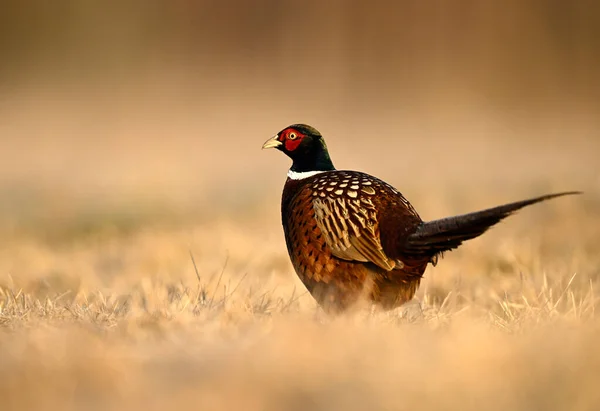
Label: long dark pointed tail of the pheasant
xmin=403 ymin=191 xmax=581 ymax=256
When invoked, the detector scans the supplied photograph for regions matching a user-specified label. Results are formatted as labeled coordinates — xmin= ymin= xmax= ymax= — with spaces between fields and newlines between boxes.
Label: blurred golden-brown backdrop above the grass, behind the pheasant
xmin=0 ymin=0 xmax=600 ymax=237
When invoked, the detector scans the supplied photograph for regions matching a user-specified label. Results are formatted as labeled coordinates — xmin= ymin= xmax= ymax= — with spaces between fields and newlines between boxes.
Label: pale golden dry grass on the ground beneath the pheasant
xmin=0 ymin=227 xmax=600 ymax=410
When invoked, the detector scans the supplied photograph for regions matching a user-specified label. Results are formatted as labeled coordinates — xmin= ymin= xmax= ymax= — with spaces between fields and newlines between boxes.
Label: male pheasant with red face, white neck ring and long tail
xmin=263 ymin=124 xmax=576 ymax=311
